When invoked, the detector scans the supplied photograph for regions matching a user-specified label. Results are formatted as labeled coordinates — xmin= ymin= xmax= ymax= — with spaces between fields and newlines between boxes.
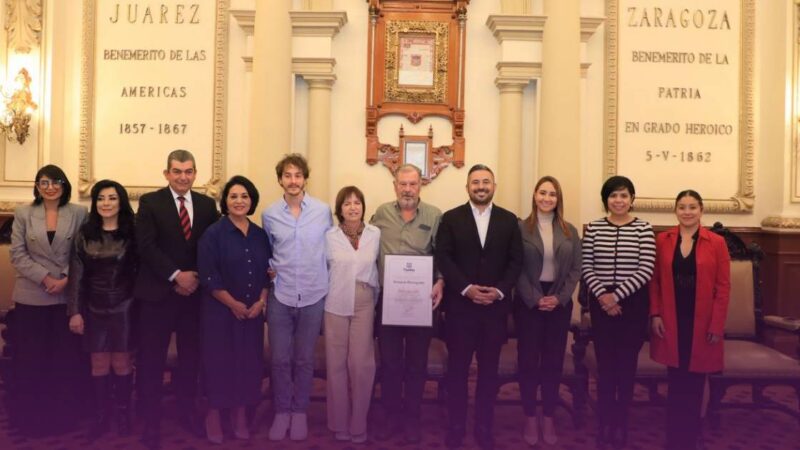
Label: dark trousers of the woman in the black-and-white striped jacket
xmin=589 ymin=288 xmax=650 ymax=428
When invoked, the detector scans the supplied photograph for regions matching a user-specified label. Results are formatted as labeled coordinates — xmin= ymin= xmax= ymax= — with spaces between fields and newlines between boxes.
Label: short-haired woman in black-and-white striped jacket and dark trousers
xmin=581 ymin=176 xmax=656 ymax=448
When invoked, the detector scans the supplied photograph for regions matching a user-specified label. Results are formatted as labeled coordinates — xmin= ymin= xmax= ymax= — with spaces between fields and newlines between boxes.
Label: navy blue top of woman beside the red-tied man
xmin=197 ymin=216 xmax=272 ymax=306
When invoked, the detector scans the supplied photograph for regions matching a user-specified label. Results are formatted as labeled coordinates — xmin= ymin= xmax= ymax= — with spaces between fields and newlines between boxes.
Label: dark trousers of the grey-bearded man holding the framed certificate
xmin=378 ymin=325 xmax=434 ymax=419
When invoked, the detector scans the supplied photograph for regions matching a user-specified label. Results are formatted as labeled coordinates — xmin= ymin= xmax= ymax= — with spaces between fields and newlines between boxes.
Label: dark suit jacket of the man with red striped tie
xmin=134 ymin=187 xmax=219 ymax=301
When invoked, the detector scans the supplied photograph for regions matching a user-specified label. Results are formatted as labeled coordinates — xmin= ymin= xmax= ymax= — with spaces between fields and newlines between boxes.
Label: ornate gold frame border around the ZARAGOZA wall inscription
xmin=603 ymin=0 xmax=755 ymax=213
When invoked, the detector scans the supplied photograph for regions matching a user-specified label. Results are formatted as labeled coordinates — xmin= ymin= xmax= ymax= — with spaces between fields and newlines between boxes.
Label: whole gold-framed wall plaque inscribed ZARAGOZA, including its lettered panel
xmin=605 ymin=0 xmax=755 ymax=213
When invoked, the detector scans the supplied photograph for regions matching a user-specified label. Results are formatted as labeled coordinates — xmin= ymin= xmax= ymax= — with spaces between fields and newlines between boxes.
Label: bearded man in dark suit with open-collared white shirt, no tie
xmin=436 ymin=164 xmax=522 ymax=449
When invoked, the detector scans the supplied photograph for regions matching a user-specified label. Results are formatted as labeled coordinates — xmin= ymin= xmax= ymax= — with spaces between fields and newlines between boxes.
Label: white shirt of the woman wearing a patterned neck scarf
xmin=325 ymin=224 xmax=381 ymax=316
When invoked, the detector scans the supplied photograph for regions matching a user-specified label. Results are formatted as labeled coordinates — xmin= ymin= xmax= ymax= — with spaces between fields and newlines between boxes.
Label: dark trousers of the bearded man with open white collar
xmin=445 ymin=311 xmax=507 ymax=430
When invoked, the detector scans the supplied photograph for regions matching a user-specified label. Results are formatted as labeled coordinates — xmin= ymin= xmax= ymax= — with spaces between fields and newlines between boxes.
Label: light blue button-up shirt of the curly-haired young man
xmin=261 ymin=194 xmax=333 ymax=308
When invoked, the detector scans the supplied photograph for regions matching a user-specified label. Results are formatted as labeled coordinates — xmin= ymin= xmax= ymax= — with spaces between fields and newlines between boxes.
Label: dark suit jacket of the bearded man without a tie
xmin=436 ymin=203 xmax=522 ymax=314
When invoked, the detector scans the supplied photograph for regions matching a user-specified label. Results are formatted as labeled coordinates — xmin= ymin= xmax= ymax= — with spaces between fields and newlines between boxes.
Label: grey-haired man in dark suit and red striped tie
xmin=134 ymin=150 xmax=219 ymax=448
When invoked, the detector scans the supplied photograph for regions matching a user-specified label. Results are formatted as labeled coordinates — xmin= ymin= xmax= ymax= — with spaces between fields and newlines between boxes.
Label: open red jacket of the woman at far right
xmin=650 ymin=227 xmax=731 ymax=373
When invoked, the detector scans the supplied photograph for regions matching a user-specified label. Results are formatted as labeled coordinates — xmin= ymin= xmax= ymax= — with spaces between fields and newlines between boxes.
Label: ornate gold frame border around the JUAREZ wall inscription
xmin=77 ymin=0 xmax=230 ymax=200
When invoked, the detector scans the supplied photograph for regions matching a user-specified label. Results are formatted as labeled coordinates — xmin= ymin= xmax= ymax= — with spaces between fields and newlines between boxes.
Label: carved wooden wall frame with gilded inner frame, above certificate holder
xmin=366 ymin=0 xmax=469 ymax=183
